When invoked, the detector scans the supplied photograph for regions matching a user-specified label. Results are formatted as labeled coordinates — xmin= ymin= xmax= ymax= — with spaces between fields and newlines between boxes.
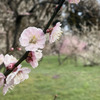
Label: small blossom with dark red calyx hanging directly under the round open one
xmin=26 ymin=50 xmax=42 ymax=68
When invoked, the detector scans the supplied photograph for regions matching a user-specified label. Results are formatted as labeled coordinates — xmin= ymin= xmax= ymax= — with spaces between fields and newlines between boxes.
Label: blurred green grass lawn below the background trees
xmin=0 ymin=56 xmax=100 ymax=100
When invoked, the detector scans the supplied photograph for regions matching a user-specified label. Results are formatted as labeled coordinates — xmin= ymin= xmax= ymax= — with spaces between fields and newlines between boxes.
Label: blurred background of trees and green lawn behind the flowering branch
xmin=0 ymin=0 xmax=100 ymax=100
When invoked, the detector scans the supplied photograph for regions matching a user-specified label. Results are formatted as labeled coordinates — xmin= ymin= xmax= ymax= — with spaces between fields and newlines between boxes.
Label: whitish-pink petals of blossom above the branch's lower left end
xmin=4 ymin=54 xmax=17 ymax=67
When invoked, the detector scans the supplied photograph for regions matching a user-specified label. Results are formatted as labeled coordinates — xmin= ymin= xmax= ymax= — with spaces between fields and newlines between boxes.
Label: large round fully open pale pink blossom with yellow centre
xmin=19 ymin=27 xmax=46 ymax=51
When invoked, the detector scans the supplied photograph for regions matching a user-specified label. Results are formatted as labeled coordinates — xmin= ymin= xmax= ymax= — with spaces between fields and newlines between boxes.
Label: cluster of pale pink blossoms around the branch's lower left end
xmin=0 ymin=54 xmax=30 ymax=95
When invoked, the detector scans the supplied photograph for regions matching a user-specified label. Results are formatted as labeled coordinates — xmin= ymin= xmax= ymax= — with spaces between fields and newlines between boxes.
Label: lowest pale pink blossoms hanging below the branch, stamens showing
xmin=3 ymin=65 xmax=31 ymax=95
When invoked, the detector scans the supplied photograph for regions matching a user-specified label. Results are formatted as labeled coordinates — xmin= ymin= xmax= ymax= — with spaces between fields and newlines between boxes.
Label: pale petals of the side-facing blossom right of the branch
xmin=49 ymin=22 xmax=62 ymax=43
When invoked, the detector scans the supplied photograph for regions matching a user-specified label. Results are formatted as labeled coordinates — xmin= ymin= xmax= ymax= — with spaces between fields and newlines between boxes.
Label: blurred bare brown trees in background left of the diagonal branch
xmin=0 ymin=0 xmax=64 ymax=53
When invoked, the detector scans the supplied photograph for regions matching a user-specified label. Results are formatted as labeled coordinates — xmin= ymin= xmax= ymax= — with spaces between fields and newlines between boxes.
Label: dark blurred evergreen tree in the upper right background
xmin=67 ymin=0 xmax=100 ymax=30
